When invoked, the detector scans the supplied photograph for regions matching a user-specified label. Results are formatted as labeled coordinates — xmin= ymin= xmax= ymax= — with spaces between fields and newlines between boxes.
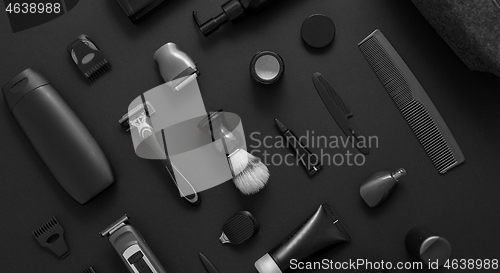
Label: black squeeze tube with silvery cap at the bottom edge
xmin=255 ymin=202 xmax=352 ymax=273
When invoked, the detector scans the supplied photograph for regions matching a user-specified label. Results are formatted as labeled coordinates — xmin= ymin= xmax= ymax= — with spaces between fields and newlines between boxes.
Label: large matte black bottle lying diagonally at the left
xmin=2 ymin=69 xmax=114 ymax=204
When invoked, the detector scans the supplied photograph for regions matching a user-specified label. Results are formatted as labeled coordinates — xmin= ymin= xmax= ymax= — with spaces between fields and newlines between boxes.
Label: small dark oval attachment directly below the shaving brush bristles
xmin=219 ymin=211 xmax=260 ymax=245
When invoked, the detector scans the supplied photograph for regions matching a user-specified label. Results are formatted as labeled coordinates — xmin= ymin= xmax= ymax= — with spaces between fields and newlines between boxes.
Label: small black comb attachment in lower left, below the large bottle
xmin=33 ymin=217 xmax=71 ymax=258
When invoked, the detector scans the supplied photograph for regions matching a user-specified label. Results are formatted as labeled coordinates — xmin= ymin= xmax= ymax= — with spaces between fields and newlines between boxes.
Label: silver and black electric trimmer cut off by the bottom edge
xmin=100 ymin=214 xmax=167 ymax=273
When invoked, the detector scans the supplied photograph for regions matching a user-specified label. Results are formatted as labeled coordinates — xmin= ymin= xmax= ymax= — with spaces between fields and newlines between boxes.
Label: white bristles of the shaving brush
xmin=229 ymin=149 xmax=270 ymax=195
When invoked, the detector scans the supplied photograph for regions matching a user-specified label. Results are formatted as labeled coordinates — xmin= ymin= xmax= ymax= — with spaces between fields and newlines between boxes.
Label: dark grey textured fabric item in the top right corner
xmin=412 ymin=0 xmax=500 ymax=77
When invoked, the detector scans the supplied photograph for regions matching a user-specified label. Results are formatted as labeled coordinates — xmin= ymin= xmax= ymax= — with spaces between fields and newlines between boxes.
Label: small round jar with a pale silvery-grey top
xmin=250 ymin=50 xmax=285 ymax=85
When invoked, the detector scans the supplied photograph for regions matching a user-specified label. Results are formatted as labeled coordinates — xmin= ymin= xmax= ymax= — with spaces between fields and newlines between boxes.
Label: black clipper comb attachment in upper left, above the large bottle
xmin=68 ymin=34 xmax=111 ymax=82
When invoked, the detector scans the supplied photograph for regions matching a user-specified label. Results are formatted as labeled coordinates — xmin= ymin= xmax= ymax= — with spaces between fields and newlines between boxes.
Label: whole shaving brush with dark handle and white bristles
xmin=198 ymin=110 xmax=270 ymax=195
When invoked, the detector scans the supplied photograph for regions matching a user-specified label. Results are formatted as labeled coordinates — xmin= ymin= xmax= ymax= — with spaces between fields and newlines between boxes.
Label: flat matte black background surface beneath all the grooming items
xmin=0 ymin=0 xmax=500 ymax=273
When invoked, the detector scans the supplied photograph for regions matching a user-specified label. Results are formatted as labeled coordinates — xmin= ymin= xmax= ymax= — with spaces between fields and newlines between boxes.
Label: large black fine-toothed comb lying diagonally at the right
xmin=358 ymin=29 xmax=465 ymax=174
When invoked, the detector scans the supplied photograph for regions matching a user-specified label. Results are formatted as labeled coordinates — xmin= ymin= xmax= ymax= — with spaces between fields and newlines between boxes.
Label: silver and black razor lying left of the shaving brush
xmin=119 ymin=99 xmax=201 ymax=205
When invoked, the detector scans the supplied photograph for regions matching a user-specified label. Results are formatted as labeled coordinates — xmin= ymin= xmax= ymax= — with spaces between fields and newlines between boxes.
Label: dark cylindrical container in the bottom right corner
xmin=405 ymin=227 xmax=451 ymax=267
